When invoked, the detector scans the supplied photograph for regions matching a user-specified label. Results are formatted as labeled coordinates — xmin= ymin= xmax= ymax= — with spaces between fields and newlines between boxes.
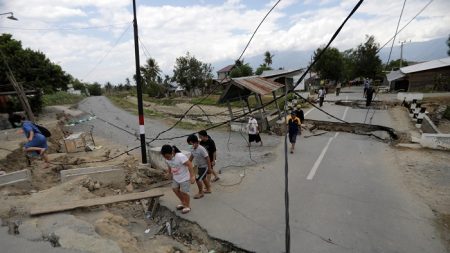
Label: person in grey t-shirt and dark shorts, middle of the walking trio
xmin=187 ymin=134 xmax=212 ymax=199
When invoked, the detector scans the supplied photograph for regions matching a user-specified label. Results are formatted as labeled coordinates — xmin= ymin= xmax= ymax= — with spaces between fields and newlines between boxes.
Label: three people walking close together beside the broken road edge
xmin=161 ymin=130 xmax=220 ymax=214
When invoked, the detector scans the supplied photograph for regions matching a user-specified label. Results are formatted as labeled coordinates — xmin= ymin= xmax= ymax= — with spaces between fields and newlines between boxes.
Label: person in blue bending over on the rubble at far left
xmin=19 ymin=116 xmax=49 ymax=168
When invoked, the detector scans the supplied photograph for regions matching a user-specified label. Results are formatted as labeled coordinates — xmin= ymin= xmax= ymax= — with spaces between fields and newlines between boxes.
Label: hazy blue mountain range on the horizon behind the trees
xmin=212 ymin=37 xmax=448 ymax=75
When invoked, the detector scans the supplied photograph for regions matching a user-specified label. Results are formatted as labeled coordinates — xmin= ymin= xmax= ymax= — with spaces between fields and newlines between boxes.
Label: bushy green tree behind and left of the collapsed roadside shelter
xmin=172 ymin=52 xmax=213 ymax=92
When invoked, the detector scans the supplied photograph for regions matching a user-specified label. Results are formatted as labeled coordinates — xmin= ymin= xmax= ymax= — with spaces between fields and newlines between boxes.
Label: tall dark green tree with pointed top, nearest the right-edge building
xmin=354 ymin=35 xmax=382 ymax=79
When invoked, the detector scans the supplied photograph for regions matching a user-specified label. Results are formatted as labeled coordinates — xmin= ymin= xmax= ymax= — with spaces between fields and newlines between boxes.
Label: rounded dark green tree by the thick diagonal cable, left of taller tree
xmin=313 ymin=47 xmax=344 ymax=81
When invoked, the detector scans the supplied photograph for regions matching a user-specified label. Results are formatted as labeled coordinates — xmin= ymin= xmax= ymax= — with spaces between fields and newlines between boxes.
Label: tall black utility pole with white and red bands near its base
xmin=133 ymin=0 xmax=147 ymax=164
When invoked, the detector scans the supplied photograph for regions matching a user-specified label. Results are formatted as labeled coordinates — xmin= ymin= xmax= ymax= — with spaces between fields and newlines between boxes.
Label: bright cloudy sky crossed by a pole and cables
xmin=0 ymin=0 xmax=450 ymax=83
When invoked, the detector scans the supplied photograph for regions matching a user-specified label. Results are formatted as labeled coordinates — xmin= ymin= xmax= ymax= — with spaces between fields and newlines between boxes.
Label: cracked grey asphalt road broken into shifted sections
xmin=74 ymin=97 xmax=446 ymax=253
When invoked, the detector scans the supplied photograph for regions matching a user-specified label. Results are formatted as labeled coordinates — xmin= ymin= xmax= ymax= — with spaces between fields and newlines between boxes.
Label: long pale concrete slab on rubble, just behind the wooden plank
xmin=61 ymin=166 xmax=125 ymax=186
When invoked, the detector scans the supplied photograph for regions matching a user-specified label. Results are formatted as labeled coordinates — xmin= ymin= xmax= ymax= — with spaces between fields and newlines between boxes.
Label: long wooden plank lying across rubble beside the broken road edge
xmin=30 ymin=189 xmax=164 ymax=215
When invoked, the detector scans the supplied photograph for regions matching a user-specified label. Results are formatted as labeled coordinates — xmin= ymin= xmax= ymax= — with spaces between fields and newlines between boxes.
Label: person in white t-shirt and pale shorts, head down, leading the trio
xmin=161 ymin=145 xmax=195 ymax=214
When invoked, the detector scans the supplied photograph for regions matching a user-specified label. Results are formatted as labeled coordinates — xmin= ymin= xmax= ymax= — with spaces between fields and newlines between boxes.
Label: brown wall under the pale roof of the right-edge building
xmin=407 ymin=66 xmax=450 ymax=92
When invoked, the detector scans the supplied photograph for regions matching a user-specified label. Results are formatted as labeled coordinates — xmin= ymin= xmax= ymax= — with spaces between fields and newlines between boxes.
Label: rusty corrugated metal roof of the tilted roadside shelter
xmin=231 ymin=77 xmax=284 ymax=95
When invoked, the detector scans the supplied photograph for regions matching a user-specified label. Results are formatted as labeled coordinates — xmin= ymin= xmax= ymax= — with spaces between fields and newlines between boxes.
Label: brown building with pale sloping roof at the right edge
xmin=386 ymin=57 xmax=450 ymax=92
